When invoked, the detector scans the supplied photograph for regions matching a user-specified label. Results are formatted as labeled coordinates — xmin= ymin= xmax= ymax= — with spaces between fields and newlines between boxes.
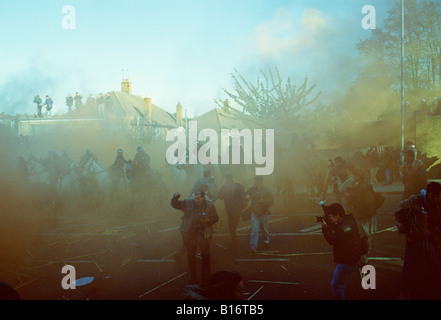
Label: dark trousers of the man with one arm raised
xmin=183 ymin=233 xmax=211 ymax=281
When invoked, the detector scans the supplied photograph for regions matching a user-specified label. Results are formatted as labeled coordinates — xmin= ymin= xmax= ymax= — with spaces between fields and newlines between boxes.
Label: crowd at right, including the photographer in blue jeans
xmin=321 ymin=142 xmax=441 ymax=299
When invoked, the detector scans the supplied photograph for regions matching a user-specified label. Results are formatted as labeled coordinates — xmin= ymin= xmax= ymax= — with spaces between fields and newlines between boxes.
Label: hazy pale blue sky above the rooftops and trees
xmin=0 ymin=0 xmax=396 ymax=117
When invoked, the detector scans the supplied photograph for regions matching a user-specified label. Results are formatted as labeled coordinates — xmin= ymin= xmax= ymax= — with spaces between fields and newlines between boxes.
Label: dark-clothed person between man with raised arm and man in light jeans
xmin=218 ymin=174 xmax=245 ymax=246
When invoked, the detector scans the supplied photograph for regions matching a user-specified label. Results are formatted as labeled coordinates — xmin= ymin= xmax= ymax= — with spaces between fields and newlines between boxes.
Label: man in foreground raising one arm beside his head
xmin=171 ymin=190 xmax=219 ymax=283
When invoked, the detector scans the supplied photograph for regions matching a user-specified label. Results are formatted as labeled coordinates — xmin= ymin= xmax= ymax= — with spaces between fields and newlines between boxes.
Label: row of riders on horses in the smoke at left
xmin=13 ymin=146 xmax=161 ymax=206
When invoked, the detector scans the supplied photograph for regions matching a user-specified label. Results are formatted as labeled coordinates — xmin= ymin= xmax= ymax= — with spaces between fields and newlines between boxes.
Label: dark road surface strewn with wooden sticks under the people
xmin=0 ymin=185 xmax=405 ymax=300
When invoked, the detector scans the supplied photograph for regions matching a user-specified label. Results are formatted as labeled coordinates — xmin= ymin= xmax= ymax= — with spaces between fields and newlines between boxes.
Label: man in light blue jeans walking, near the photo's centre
xmin=245 ymin=176 xmax=274 ymax=255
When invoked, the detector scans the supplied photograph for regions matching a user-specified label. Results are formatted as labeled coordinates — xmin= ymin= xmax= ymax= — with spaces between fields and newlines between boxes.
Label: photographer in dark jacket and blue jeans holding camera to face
xmin=319 ymin=203 xmax=362 ymax=300
